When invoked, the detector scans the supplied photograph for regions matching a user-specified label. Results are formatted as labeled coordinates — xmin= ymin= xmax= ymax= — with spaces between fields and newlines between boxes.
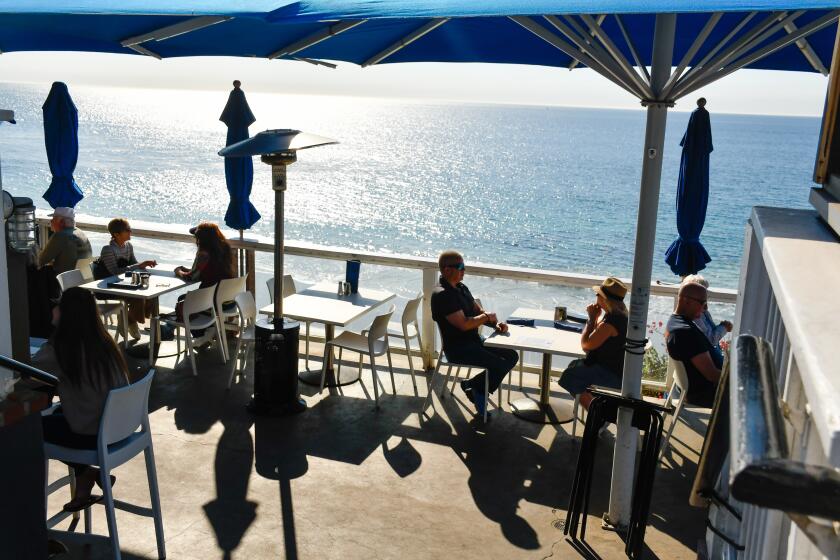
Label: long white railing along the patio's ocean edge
xmin=37 ymin=211 xmax=737 ymax=372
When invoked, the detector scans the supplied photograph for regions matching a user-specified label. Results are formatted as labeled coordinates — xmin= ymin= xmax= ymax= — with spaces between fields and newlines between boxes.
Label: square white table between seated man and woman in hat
xmin=484 ymin=307 xmax=585 ymax=424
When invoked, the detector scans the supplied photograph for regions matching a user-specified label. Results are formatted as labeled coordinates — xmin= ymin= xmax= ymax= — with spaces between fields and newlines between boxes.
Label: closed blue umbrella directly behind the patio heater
xmin=219 ymin=80 xmax=260 ymax=231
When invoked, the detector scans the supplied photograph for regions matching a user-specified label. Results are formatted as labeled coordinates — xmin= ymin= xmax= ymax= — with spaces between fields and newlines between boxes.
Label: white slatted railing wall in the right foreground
xmin=707 ymin=208 xmax=840 ymax=559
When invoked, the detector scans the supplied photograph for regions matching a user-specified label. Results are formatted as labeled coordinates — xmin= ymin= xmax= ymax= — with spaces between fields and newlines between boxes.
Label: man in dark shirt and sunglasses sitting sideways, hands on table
xmin=432 ymin=251 xmax=519 ymax=415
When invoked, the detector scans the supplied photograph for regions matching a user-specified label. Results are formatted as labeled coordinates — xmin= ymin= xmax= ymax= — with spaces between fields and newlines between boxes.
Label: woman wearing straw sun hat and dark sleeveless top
xmin=559 ymin=277 xmax=627 ymax=408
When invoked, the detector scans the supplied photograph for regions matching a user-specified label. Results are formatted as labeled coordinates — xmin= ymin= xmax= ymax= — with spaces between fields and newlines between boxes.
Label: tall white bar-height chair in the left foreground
xmin=44 ymin=369 xmax=166 ymax=560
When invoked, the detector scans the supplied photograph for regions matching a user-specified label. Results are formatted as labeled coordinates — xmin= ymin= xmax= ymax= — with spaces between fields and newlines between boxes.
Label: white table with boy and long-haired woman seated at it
xmin=81 ymin=264 xmax=198 ymax=364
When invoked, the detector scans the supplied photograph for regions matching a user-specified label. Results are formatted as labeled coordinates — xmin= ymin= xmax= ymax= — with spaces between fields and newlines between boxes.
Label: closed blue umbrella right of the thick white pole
xmin=665 ymin=97 xmax=714 ymax=276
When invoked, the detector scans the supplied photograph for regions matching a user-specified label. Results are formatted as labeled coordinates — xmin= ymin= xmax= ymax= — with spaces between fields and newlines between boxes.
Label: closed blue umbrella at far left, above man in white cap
xmin=43 ymin=82 xmax=85 ymax=208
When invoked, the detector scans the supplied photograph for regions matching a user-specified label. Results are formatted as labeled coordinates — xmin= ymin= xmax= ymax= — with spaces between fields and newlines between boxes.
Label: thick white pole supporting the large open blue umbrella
xmin=605 ymin=14 xmax=676 ymax=530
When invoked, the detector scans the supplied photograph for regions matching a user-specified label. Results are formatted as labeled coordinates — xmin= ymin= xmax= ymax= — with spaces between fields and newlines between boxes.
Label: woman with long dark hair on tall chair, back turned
xmin=33 ymin=287 xmax=129 ymax=511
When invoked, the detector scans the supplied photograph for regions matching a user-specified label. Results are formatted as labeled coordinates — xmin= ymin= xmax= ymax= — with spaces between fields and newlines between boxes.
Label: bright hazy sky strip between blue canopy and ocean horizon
xmin=0 ymin=53 xmax=828 ymax=115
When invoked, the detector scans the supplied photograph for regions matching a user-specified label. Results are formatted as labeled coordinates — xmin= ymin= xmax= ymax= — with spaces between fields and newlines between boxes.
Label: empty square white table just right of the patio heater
xmin=260 ymin=281 xmax=395 ymax=387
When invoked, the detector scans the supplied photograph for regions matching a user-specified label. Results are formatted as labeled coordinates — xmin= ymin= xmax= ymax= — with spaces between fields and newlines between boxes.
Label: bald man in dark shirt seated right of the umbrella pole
xmin=666 ymin=284 xmax=723 ymax=408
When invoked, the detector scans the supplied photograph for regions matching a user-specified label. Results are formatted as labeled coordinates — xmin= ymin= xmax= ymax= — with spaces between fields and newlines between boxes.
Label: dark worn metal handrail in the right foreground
xmin=729 ymin=335 xmax=840 ymax=521
